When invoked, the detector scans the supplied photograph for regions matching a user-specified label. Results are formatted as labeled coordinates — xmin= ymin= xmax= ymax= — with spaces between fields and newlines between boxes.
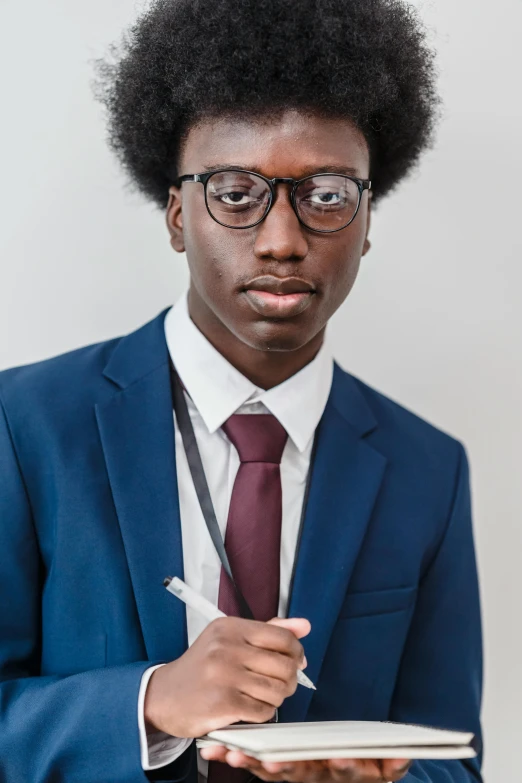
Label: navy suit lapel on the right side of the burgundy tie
xmin=279 ymin=367 xmax=386 ymax=722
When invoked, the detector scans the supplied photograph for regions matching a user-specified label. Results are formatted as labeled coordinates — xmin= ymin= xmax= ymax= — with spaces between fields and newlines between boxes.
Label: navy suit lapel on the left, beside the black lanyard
xmin=96 ymin=312 xmax=187 ymax=661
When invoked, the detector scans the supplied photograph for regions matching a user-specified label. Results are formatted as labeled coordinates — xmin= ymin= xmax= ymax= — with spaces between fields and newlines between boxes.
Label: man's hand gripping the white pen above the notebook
xmin=144 ymin=617 xmax=310 ymax=737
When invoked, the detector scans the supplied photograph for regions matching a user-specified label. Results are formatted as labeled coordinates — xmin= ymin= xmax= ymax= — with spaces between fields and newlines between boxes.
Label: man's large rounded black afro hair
xmin=95 ymin=0 xmax=439 ymax=208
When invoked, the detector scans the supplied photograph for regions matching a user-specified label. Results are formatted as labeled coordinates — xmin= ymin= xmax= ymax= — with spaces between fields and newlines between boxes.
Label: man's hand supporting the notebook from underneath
xmin=200 ymin=745 xmax=411 ymax=783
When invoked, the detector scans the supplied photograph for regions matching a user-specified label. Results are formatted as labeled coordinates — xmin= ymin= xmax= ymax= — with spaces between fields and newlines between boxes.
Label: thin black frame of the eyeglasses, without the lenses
xmin=176 ymin=169 xmax=372 ymax=234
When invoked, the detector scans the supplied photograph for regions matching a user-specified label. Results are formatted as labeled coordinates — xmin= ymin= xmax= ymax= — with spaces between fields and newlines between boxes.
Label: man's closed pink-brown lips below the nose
xmin=244 ymin=275 xmax=315 ymax=318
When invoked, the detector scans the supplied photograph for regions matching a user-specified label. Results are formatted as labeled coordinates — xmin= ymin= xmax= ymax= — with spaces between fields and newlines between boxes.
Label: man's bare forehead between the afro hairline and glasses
xmin=179 ymin=110 xmax=370 ymax=179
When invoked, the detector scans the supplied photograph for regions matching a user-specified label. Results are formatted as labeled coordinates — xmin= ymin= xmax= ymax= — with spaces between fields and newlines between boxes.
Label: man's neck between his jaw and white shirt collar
xmin=188 ymin=288 xmax=325 ymax=389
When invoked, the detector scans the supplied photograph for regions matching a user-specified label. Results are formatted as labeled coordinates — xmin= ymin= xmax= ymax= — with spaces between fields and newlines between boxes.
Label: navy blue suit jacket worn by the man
xmin=0 ymin=311 xmax=482 ymax=783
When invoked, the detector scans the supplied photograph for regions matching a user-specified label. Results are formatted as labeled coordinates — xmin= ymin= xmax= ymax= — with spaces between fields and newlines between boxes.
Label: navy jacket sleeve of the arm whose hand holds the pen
xmin=0 ymin=402 xmax=193 ymax=783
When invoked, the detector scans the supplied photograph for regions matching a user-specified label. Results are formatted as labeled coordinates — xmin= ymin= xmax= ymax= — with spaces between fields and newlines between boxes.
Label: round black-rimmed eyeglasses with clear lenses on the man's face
xmin=178 ymin=169 xmax=372 ymax=233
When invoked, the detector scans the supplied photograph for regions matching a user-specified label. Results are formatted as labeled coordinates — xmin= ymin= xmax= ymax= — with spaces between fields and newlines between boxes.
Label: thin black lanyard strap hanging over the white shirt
xmin=170 ymin=361 xmax=317 ymax=620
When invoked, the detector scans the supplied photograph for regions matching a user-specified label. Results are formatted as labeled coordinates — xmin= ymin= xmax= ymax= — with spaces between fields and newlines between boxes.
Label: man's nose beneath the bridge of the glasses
xmin=254 ymin=183 xmax=308 ymax=261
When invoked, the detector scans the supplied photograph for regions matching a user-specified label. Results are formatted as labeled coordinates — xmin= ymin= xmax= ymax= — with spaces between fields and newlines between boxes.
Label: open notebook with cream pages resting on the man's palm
xmin=193 ymin=721 xmax=476 ymax=761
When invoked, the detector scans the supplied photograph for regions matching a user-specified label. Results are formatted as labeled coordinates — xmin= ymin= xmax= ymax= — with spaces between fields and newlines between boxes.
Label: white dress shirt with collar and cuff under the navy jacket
xmin=138 ymin=294 xmax=333 ymax=776
